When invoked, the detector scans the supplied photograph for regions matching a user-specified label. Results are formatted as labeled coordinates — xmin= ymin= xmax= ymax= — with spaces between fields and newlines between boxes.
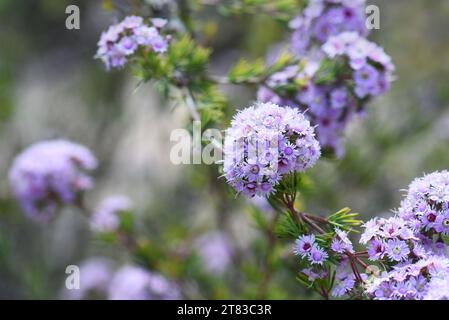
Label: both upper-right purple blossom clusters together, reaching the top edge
xmin=258 ymin=0 xmax=394 ymax=157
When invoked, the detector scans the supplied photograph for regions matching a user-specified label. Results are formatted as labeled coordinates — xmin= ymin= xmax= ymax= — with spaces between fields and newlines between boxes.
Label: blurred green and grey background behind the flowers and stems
xmin=0 ymin=0 xmax=449 ymax=299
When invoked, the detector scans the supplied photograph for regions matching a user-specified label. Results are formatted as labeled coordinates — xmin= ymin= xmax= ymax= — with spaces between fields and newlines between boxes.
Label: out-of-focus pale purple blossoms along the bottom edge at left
xmin=62 ymin=258 xmax=181 ymax=300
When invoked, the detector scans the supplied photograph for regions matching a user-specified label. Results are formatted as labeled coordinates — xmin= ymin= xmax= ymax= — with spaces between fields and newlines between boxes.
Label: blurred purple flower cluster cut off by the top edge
xmin=290 ymin=0 xmax=368 ymax=55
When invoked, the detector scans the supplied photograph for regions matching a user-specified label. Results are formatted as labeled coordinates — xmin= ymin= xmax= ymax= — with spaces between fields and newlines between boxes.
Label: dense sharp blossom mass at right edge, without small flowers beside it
xmin=354 ymin=171 xmax=449 ymax=300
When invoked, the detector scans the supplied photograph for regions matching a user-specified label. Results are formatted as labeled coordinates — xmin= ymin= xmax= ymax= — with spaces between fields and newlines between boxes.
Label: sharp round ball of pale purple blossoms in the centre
xmin=224 ymin=103 xmax=320 ymax=197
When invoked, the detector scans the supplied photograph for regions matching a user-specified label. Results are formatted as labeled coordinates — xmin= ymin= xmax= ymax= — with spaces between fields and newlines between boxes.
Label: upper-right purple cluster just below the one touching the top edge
xmin=258 ymin=32 xmax=394 ymax=156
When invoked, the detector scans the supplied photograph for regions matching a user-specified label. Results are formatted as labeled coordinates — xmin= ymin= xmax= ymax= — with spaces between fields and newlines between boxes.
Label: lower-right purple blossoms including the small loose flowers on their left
xmin=294 ymin=171 xmax=449 ymax=300
